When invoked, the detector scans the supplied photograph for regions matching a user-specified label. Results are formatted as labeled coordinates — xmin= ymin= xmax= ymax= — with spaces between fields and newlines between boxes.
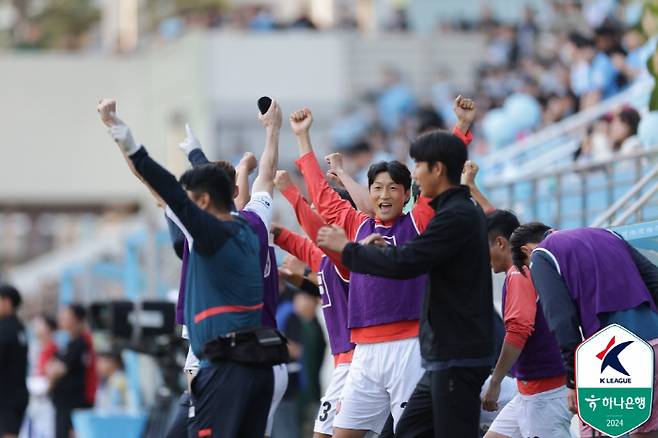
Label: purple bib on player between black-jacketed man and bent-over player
xmin=503 ymin=268 xmax=565 ymax=380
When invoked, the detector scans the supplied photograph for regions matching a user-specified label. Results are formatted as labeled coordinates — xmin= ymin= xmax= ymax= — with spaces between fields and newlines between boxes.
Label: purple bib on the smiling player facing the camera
xmin=348 ymin=214 xmax=427 ymax=328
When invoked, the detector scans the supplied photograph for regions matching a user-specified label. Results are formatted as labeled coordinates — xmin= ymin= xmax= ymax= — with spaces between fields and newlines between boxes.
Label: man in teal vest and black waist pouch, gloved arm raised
xmin=99 ymin=102 xmax=274 ymax=438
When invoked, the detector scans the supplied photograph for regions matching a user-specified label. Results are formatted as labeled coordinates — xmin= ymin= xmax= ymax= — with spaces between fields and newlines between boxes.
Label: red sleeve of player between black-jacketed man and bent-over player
xmin=504 ymin=269 xmax=537 ymax=348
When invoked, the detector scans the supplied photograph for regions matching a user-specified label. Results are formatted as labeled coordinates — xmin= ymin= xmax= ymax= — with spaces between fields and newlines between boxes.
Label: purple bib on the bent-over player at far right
xmin=535 ymin=228 xmax=657 ymax=338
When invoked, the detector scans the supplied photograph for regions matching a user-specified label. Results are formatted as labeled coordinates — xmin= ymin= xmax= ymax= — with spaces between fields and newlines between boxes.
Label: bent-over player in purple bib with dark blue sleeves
xmin=510 ymin=222 xmax=658 ymax=438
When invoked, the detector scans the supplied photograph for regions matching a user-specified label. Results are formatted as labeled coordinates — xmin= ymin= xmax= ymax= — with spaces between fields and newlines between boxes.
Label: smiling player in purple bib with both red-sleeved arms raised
xmin=298 ymin=99 xmax=472 ymax=438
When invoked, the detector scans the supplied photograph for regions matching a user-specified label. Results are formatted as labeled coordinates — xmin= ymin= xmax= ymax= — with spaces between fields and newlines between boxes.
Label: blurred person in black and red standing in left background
xmin=46 ymin=304 xmax=96 ymax=438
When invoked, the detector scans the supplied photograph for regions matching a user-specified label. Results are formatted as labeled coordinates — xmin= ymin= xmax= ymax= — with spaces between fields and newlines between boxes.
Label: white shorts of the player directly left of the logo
xmin=489 ymin=386 xmax=573 ymax=438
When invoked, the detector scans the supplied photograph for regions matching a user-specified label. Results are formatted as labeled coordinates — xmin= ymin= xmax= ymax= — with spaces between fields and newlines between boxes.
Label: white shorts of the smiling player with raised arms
xmin=334 ymin=338 xmax=424 ymax=433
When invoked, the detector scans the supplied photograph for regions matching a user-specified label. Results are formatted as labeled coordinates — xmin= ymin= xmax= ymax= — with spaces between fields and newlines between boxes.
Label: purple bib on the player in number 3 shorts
xmin=318 ymin=256 xmax=354 ymax=355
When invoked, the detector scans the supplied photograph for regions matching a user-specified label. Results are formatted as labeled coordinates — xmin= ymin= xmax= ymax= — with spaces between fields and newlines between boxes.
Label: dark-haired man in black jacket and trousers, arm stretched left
xmin=318 ymin=125 xmax=493 ymax=438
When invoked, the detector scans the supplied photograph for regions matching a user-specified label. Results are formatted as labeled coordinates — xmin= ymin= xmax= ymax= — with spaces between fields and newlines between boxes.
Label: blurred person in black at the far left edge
xmin=0 ymin=284 xmax=28 ymax=438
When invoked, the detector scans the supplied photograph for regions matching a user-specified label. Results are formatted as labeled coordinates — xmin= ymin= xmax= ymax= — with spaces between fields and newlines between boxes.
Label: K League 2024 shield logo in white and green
xmin=576 ymin=324 xmax=654 ymax=437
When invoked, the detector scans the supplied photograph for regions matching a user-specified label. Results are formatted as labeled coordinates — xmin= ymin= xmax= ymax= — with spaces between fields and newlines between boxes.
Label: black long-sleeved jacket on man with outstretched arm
xmin=343 ymin=186 xmax=493 ymax=361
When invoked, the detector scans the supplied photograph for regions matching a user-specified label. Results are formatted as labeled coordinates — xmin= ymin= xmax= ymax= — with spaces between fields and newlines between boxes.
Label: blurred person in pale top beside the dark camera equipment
xmin=96 ymin=351 xmax=136 ymax=413
